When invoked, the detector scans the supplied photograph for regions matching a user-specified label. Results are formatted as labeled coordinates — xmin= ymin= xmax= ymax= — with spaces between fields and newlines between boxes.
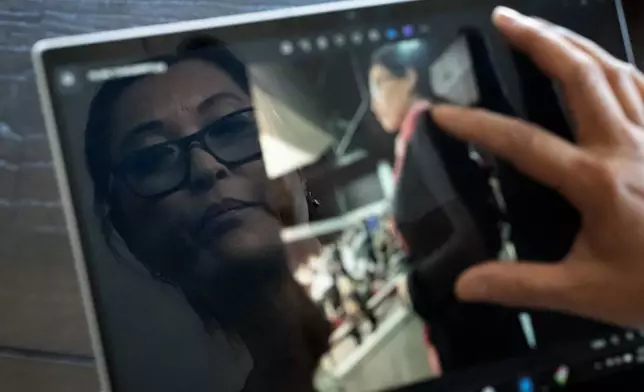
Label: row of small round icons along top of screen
xmin=279 ymin=24 xmax=431 ymax=56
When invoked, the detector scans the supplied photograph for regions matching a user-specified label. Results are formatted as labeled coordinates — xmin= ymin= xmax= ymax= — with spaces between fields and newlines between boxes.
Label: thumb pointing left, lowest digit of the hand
xmin=456 ymin=262 xmax=574 ymax=310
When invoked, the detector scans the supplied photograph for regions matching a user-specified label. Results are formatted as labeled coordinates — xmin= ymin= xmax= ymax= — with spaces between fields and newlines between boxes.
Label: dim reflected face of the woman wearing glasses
xmin=110 ymin=60 xmax=307 ymax=282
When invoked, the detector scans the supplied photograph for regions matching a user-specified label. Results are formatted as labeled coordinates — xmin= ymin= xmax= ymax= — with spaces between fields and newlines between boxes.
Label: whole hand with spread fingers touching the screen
xmin=433 ymin=7 xmax=644 ymax=327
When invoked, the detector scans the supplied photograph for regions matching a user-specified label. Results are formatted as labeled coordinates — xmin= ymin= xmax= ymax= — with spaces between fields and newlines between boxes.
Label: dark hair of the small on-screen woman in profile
xmin=371 ymin=39 xmax=429 ymax=96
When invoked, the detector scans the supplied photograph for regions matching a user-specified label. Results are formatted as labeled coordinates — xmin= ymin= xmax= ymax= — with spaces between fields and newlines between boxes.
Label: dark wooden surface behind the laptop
xmin=0 ymin=0 xmax=644 ymax=392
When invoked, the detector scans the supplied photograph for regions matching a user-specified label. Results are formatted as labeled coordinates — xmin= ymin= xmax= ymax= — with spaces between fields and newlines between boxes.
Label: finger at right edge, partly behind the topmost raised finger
xmin=546 ymin=22 xmax=644 ymax=125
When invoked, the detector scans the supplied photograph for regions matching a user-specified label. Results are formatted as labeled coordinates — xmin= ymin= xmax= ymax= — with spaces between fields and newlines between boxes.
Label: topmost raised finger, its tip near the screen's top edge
xmin=493 ymin=7 xmax=627 ymax=145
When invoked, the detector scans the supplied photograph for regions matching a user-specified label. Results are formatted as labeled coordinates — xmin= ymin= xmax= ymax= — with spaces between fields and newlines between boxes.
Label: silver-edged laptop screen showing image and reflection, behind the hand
xmin=33 ymin=0 xmax=644 ymax=392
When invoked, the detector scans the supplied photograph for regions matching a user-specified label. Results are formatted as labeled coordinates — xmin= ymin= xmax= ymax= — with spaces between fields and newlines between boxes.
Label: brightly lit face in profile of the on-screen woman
xmin=369 ymin=64 xmax=416 ymax=132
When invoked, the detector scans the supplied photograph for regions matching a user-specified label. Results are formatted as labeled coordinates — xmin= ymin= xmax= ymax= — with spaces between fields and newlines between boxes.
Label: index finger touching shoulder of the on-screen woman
xmin=432 ymin=105 xmax=592 ymax=208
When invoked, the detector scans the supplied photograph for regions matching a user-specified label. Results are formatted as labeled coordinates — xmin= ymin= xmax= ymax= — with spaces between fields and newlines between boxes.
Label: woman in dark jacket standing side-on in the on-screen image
xmin=369 ymin=40 xmax=527 ymax=374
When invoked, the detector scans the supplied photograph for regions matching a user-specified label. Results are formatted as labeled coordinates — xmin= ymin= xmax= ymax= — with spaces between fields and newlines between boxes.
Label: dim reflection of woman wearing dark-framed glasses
xmin=85 ymin=41 xmax=330 ymax=392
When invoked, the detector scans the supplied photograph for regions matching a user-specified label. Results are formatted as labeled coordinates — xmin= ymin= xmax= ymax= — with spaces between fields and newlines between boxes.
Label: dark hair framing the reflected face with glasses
xmin=85 ymin=37 xmax=250 ymax=267
